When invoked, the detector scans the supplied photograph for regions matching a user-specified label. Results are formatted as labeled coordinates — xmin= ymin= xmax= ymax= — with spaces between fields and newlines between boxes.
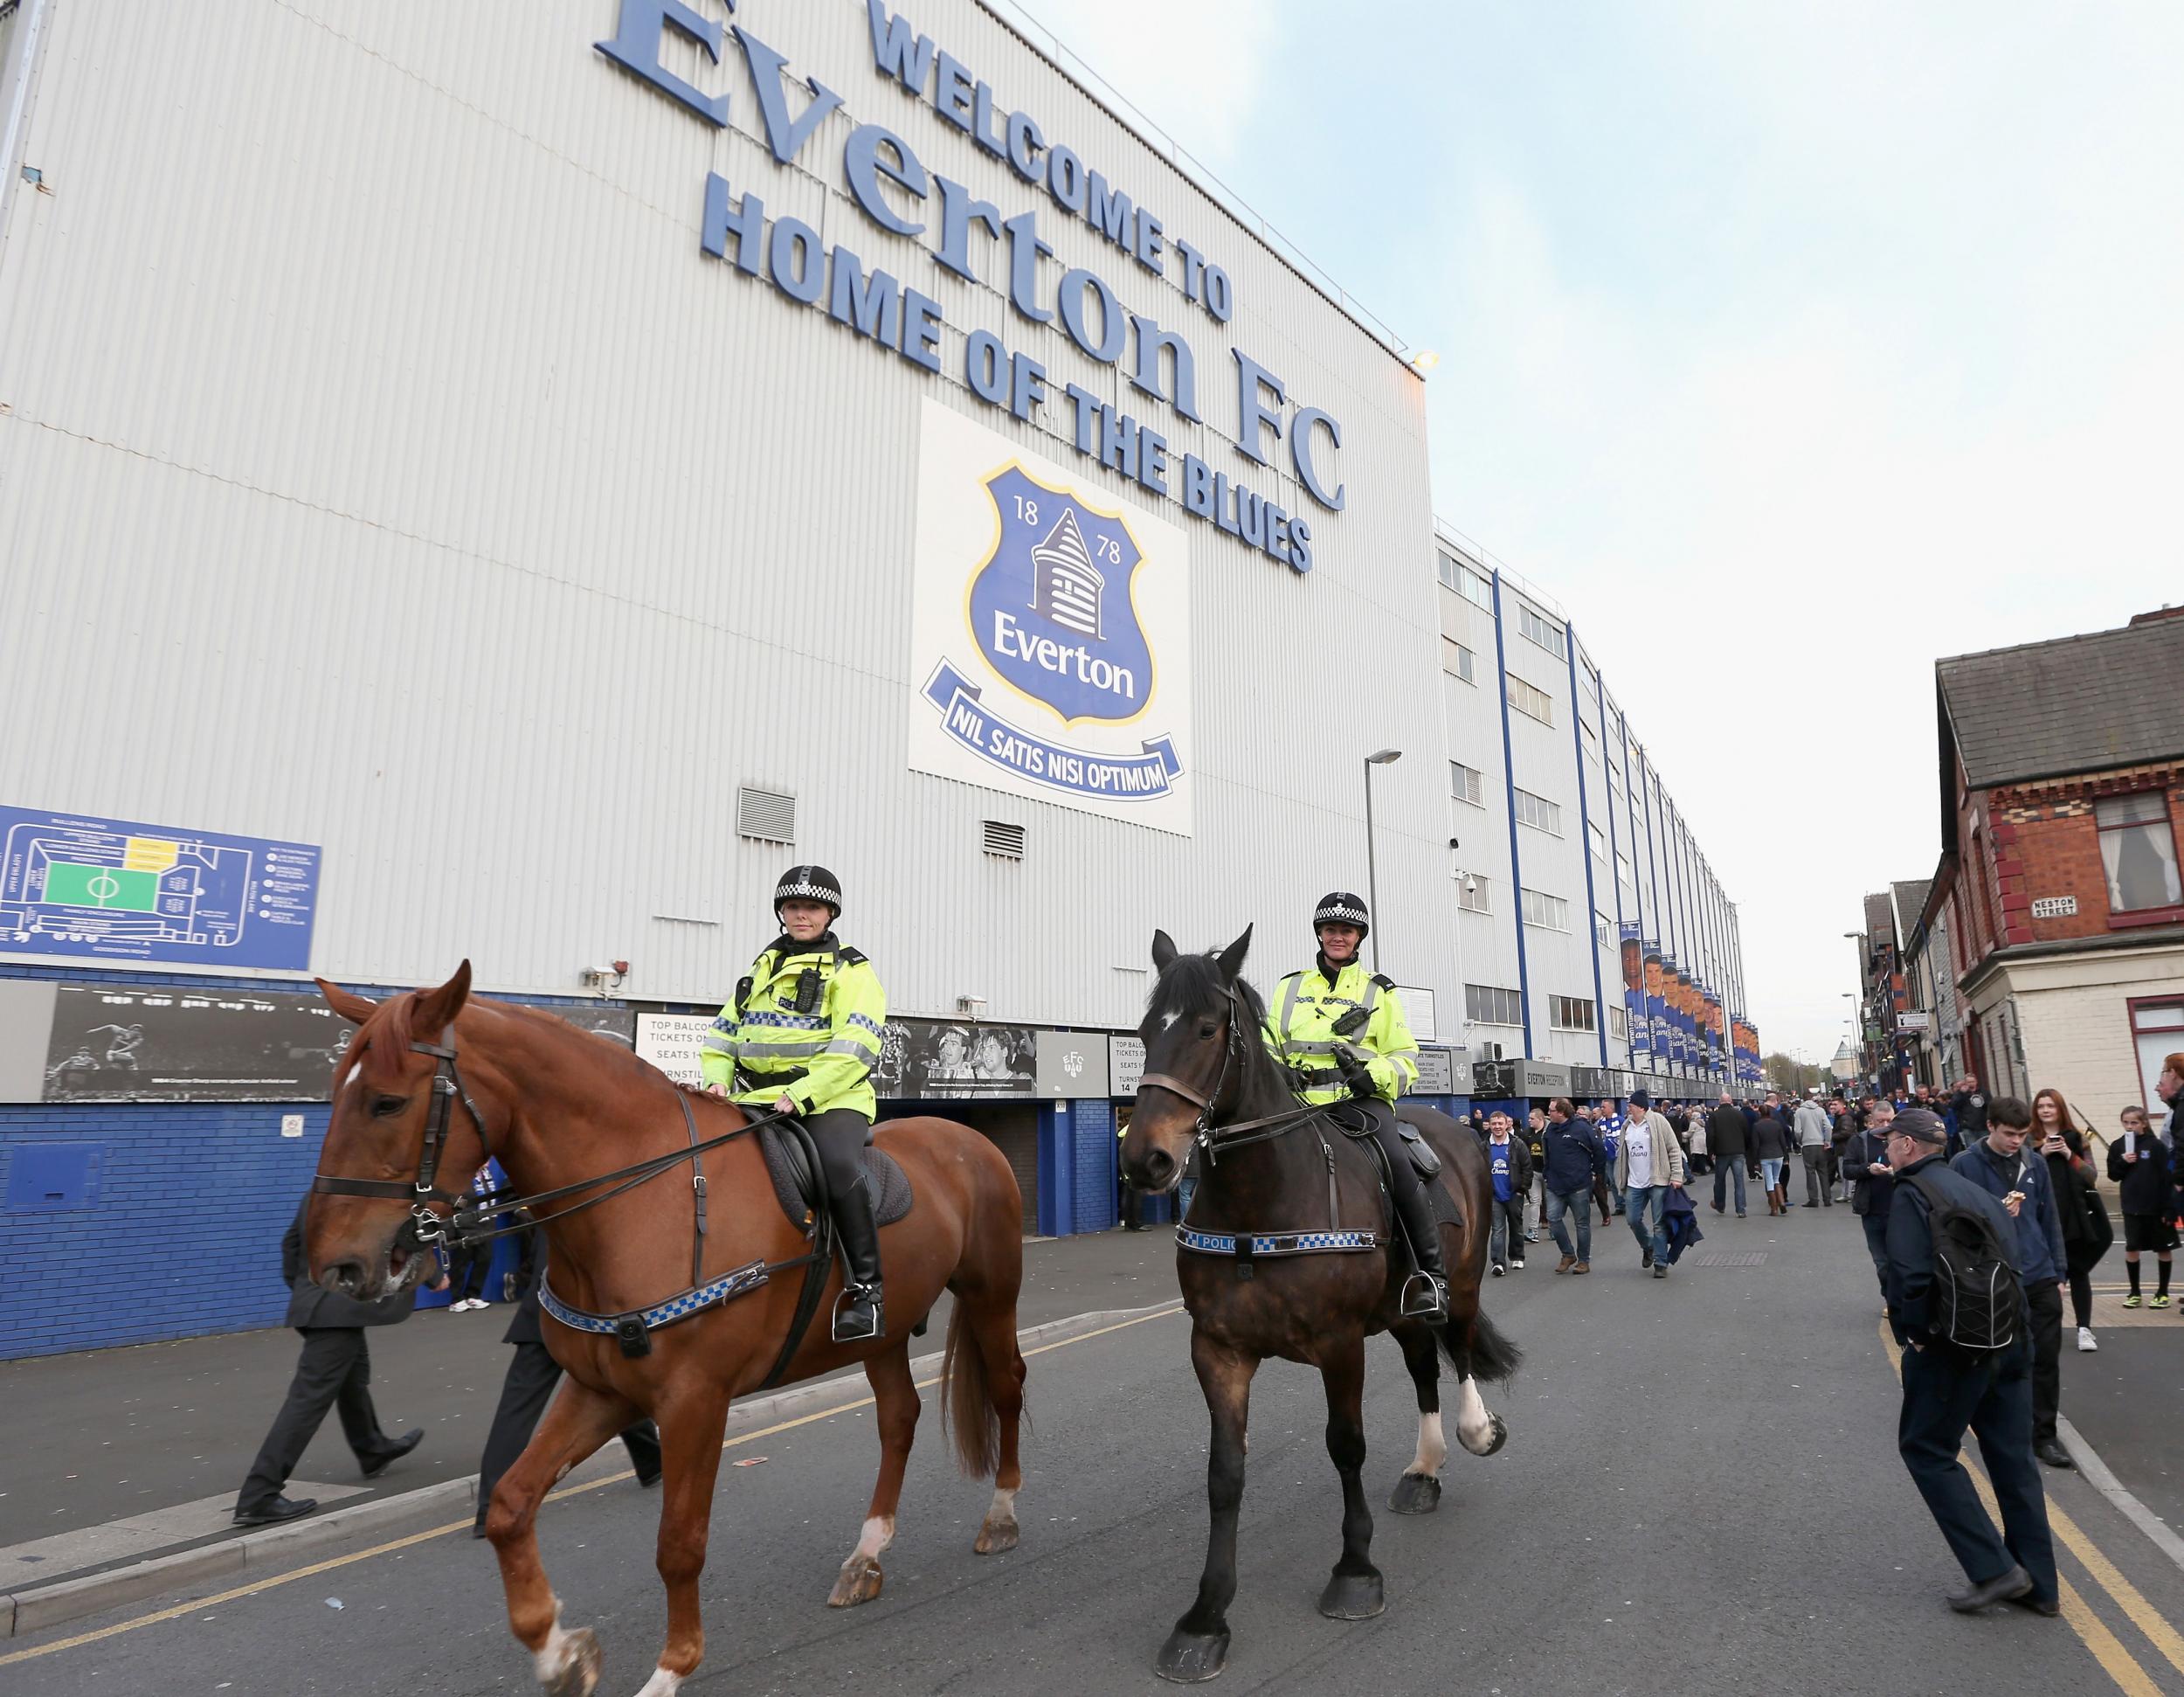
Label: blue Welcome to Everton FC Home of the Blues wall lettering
xmin=597 ymin=0 xmax=1348 ymax=572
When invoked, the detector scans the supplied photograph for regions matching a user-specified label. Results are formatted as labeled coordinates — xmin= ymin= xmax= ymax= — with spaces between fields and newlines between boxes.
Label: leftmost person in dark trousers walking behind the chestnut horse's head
xmin=236 ymin=1193 xmax=424 ymax=1527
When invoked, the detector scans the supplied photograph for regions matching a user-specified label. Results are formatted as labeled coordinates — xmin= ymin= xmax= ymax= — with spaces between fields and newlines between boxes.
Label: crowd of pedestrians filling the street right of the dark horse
xmin=1472 ymin=1053 xmax=2184 ymax=1617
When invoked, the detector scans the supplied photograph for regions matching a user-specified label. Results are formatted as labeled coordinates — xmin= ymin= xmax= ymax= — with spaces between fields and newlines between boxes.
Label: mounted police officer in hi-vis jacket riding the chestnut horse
xmin=702 ymin=865 xmax=887 ymax=1343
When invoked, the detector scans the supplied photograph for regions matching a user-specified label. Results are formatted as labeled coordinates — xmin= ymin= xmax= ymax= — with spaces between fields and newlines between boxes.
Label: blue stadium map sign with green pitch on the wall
xmin=0 ymin=808 xmax=319 ymax=972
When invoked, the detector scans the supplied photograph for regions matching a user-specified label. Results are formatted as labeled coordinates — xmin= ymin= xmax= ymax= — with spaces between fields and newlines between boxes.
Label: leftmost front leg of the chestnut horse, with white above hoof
xmin=485 ymin=1378 xmax=638 ymax=1697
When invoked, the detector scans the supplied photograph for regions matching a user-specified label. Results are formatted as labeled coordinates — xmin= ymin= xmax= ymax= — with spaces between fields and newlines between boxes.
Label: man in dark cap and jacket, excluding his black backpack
xmin=1887 ymin=1107 xmax=2062 ymax=1614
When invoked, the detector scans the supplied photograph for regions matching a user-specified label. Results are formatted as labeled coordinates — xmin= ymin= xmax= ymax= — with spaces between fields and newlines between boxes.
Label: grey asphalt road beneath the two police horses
xmin=0 ymin=1210 xmax=2184 ymax=1697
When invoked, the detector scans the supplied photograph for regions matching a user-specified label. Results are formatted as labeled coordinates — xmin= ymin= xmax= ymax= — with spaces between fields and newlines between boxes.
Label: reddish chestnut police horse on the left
xmin=306 ymin=961 xmax=1025 ymax=1697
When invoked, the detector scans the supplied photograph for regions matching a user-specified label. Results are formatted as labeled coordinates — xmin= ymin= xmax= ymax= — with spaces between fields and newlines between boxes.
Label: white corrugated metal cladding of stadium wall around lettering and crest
xmin=0 ymin=0 xmax=1462 ymax=1036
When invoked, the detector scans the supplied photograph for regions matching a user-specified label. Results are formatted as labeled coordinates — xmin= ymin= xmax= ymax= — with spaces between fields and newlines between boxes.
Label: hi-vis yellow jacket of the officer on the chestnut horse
xmin=699 ymin=932 xmax=887 ymax=1120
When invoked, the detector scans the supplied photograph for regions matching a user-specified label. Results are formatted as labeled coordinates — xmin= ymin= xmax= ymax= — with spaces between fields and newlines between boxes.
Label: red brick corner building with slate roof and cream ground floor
xmin=1925 ymin=607 xmax=2184 ymax=1136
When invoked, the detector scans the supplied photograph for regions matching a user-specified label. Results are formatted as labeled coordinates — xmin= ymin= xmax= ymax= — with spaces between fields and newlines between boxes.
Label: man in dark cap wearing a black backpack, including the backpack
xmin=1887 ymin=1107 xmax=2062 ymax=1617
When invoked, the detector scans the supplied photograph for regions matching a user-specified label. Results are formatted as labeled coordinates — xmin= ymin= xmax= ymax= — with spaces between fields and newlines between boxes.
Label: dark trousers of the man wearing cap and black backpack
xmin=1896 ymin=1337 xmax=2057 ymax=1599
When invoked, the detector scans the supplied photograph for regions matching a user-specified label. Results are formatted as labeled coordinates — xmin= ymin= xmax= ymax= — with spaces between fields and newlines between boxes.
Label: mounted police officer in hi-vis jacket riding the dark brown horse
xmin=1267 ymin=891 xmax=1448 ymax=1321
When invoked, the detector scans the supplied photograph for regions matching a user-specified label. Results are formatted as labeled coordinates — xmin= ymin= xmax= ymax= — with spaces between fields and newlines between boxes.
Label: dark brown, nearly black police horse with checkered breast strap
xmin=1123 ymin=928 xmax=1520 ymax=1680
